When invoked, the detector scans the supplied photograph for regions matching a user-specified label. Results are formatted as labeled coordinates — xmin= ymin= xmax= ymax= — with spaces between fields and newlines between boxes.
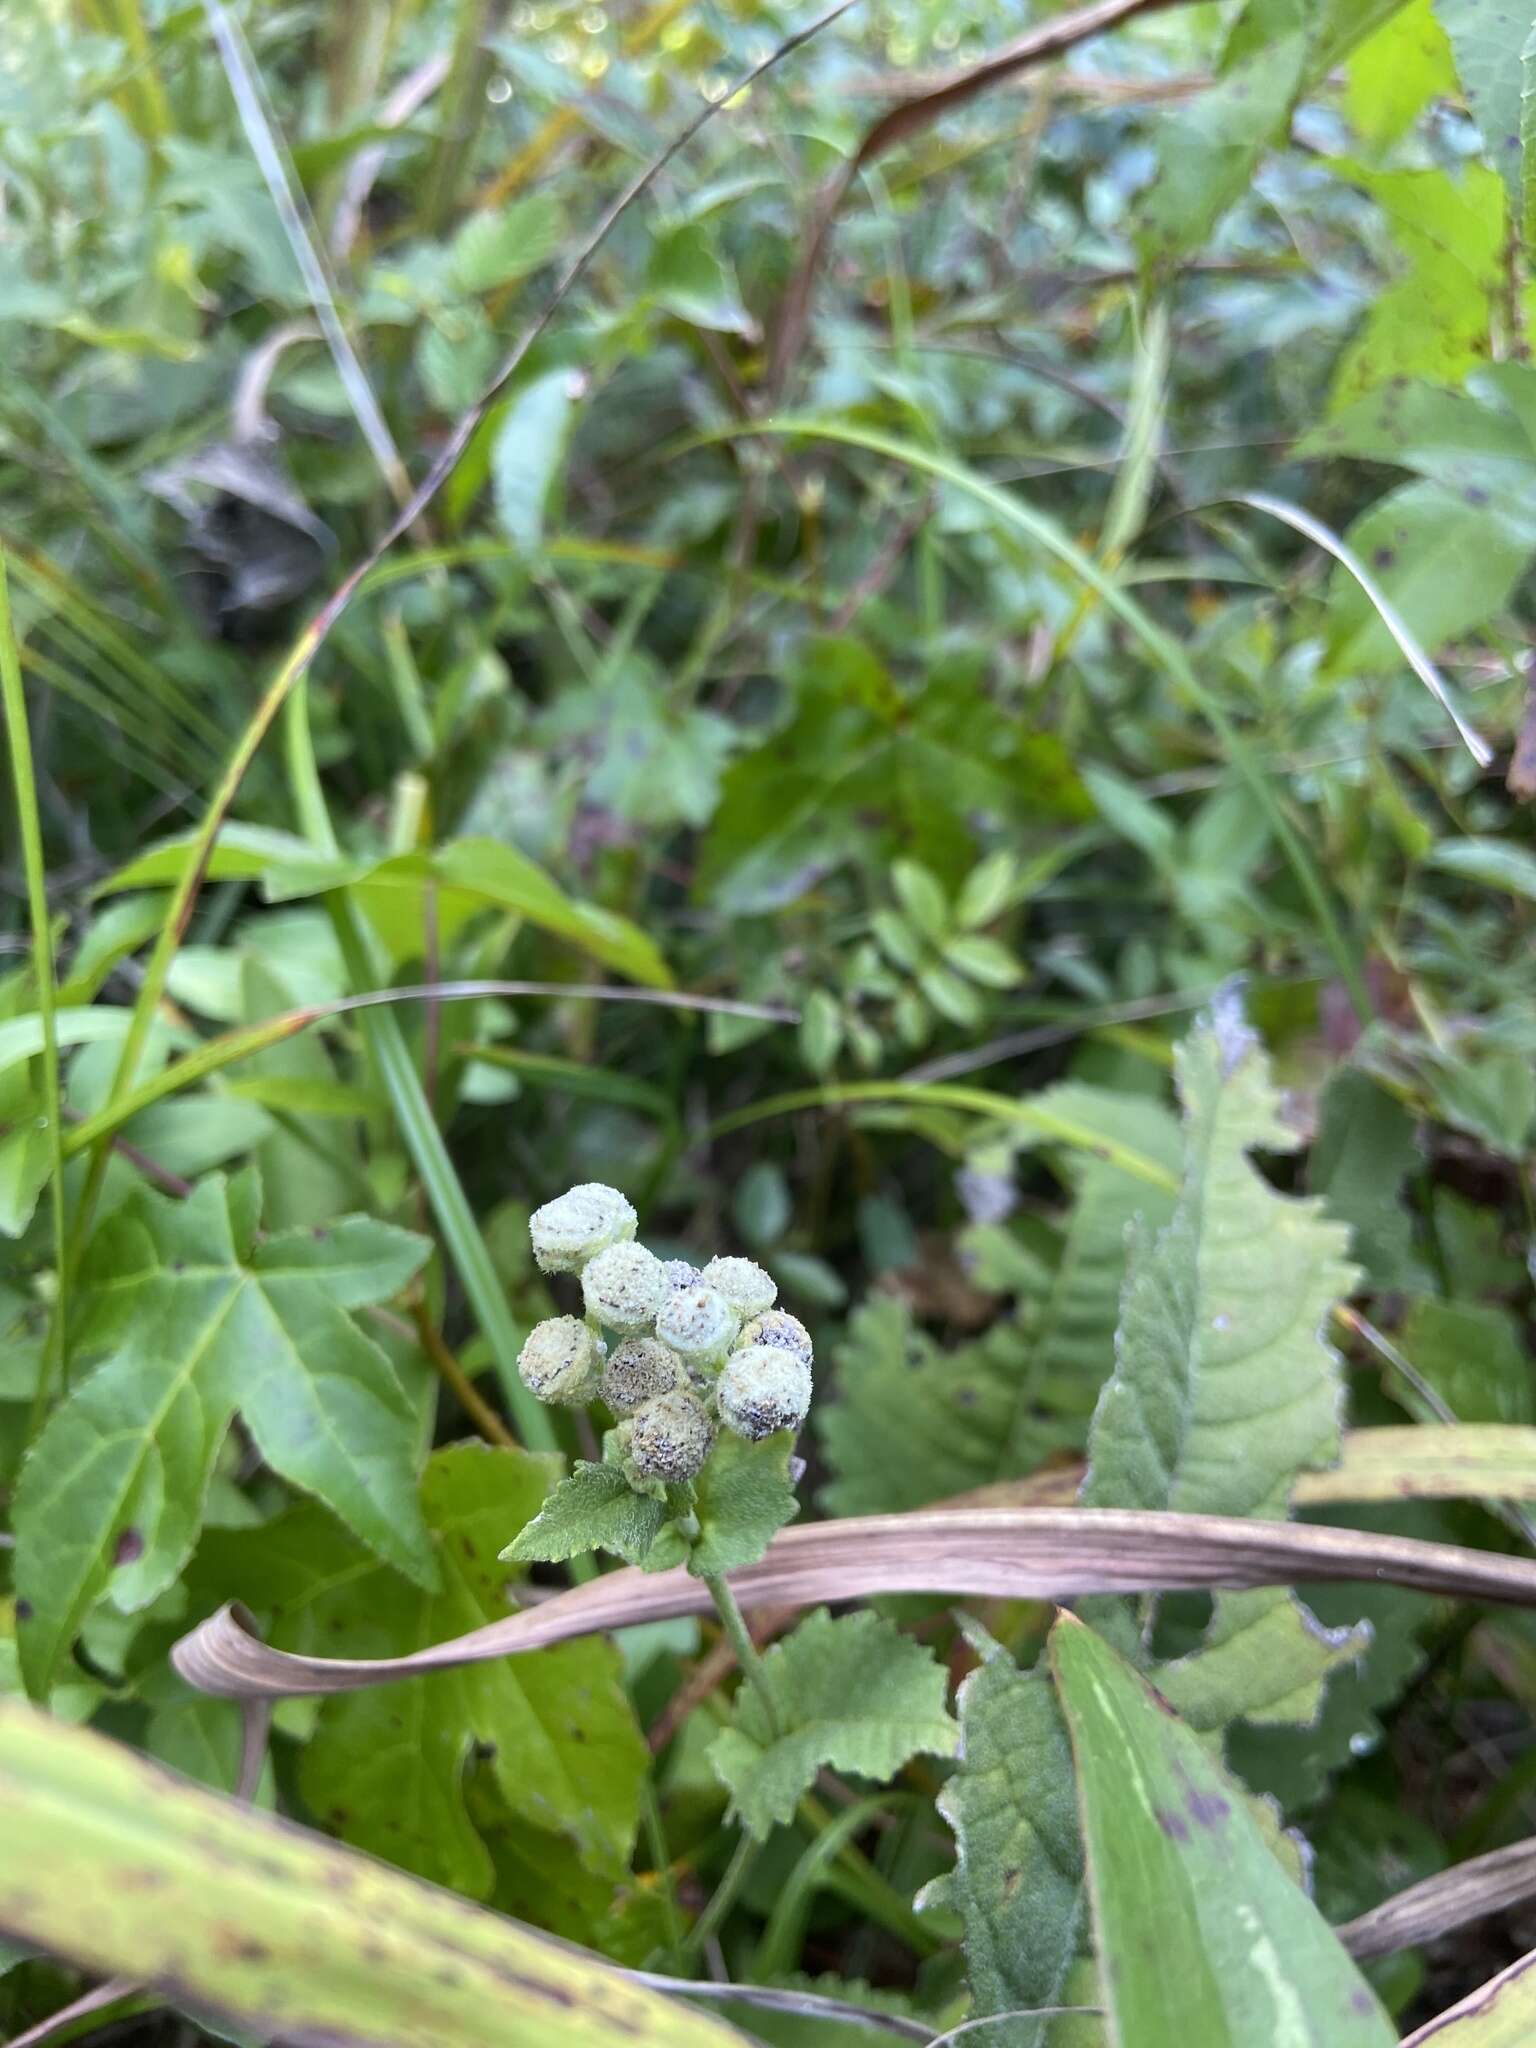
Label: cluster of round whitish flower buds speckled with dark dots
xmin=518 ymin=1182 xmax=811 ymax=1485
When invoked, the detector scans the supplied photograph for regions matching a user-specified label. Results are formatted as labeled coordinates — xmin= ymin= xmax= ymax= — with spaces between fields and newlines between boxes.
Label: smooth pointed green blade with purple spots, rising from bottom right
xmin=1051 ymin=1616 xmax=1397 ymax=2048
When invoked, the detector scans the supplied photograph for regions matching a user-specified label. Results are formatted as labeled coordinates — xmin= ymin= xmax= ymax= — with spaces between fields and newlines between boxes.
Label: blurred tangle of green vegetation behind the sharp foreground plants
xmin=0 ymin=0 xmax=1536 ymax=2040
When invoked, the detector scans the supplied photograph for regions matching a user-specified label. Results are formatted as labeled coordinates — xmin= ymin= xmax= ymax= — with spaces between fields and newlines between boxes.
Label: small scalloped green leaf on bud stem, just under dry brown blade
xmin=709 ymin=1608 xmax=961 ymax=1839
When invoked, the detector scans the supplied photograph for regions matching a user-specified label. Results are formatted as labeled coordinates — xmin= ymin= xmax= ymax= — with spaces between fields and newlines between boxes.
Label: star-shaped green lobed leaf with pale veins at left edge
xmin=16 ymin=1174 xmax=436 ymax=1692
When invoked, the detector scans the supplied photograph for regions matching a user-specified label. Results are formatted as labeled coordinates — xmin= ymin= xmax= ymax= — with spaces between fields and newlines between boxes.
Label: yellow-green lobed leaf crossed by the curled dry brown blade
xmin=199 ymin=1444 xmax=647 ymax=1898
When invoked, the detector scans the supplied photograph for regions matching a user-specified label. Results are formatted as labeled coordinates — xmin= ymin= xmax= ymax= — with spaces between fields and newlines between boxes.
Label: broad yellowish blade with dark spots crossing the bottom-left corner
xmin=0 ymin=1700 xmax=739 ymax=2048
